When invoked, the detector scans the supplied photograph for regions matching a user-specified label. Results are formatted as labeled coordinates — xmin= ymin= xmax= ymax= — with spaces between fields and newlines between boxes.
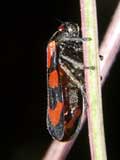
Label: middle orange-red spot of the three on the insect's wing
xmin=48 ymin=70 xmax=58 ymax=88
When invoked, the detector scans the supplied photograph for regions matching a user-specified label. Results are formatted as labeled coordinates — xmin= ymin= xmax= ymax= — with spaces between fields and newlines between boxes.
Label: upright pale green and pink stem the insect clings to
xmin=80 ymin=0 xmax=107 ymax=160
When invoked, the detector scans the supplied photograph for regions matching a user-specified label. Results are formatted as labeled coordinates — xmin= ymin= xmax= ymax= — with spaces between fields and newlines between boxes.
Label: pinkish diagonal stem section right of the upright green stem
xmin=99 ymin=2 xmax=120 ymax=83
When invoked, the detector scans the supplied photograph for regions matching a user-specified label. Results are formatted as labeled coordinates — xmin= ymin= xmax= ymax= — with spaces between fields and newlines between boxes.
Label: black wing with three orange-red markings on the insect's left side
xmin=47 ymin=41 xmax=64 ymax=140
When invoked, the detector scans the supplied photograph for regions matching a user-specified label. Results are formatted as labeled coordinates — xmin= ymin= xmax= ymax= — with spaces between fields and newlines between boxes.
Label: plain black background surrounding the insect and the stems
xmin=0 ymin=0 xmax=120 ymax=160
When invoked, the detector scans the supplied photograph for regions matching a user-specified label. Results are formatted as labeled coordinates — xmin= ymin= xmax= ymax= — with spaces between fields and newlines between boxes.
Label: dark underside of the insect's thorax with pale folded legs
xmin=57 ymin=41 xmax=84 ymax=84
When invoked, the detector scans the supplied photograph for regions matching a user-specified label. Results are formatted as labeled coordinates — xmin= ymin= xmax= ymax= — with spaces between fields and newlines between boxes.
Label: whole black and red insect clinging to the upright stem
xmin=47 ymin=22 xmax=87 ymax=141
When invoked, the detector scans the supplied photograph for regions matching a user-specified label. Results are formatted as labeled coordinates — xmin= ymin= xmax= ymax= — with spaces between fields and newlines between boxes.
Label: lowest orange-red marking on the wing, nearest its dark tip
xmin=48 ymin=102 xmax=63 ymax=126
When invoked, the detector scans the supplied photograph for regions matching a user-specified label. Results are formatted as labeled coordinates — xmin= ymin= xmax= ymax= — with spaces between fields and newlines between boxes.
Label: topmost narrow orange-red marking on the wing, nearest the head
xmin=47 ymin=41 xmax=56 ymax=68
